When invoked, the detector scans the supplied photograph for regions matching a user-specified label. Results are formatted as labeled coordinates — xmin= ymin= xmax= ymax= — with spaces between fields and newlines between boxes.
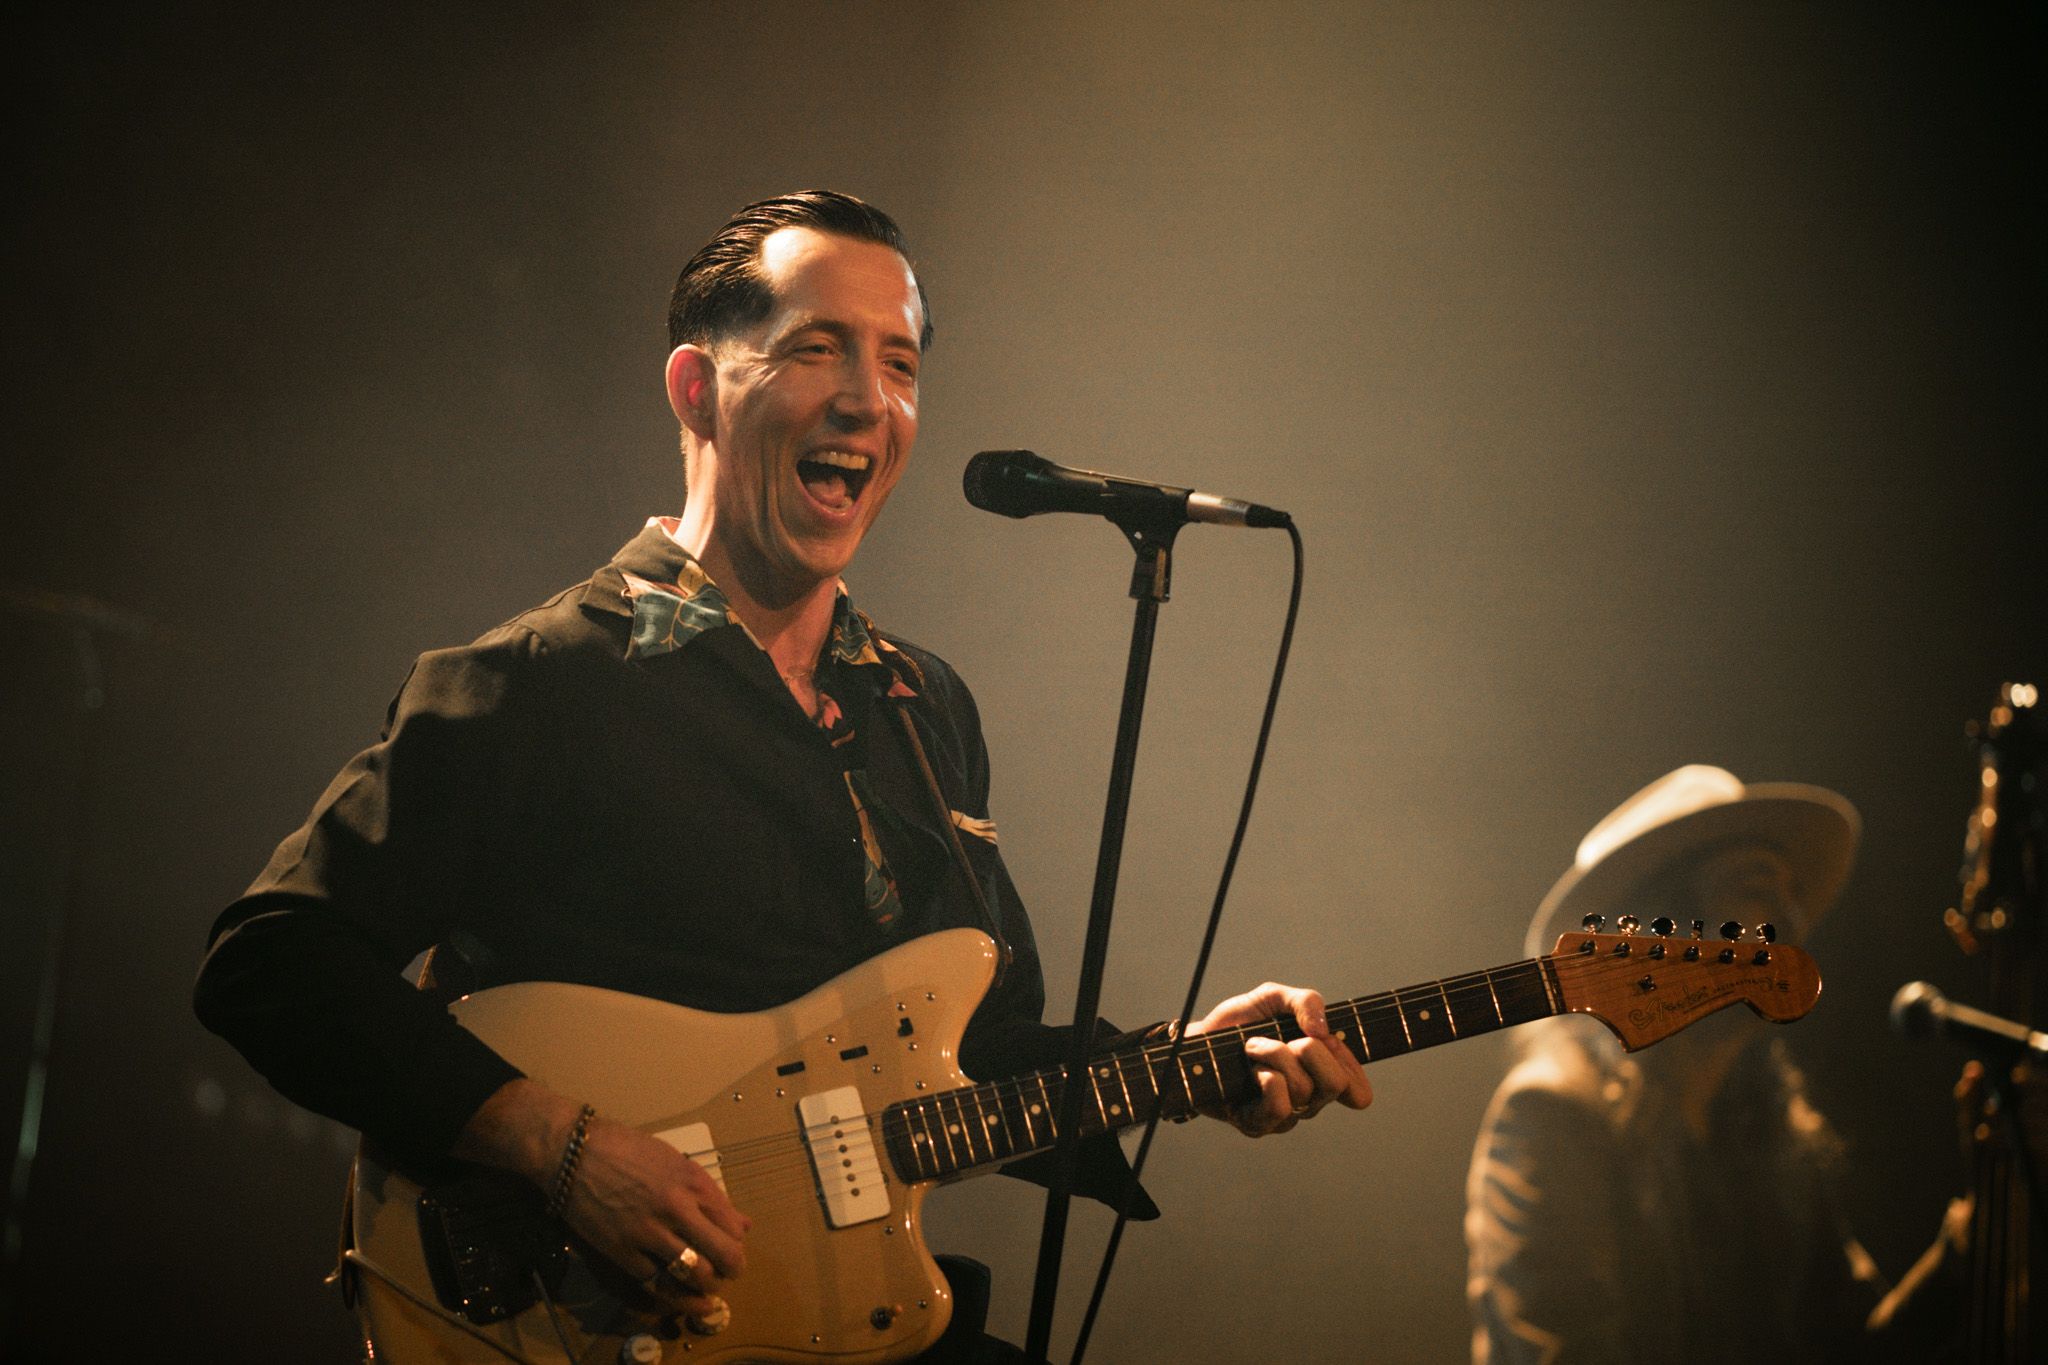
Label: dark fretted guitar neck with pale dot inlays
xmin=883 ymin=958 xmax=1567 ymax=1181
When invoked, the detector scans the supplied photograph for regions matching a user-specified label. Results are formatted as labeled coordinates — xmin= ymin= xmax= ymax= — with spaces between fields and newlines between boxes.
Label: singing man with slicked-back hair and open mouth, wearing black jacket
xmin=197 ymin=192 xmax=1370 ymax=1358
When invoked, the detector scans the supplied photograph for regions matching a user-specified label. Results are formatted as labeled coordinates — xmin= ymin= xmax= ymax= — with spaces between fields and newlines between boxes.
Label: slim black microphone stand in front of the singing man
xmin=1024 ymin=512 xmax=1182 ymax=1363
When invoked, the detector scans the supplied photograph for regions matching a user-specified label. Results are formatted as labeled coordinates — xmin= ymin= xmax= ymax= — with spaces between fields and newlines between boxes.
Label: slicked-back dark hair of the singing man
xmin=668 ymin=190 xmax=932 ymax=350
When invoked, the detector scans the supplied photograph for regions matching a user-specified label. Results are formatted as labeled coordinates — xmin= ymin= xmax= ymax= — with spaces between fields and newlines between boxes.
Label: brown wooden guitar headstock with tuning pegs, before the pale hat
xmin=1544 ymin=917 xmax=1821 ymax=1052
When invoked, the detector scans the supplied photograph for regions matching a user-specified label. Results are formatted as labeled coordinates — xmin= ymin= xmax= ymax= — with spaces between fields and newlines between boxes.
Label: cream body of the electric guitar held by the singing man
xmin=352 ymin=929 xmax=995 ymax=1365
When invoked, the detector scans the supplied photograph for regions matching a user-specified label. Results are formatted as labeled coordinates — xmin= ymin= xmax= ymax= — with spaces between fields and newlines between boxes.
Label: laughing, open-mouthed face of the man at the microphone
xmin=690 ymin=227 xmax=924 ymax=600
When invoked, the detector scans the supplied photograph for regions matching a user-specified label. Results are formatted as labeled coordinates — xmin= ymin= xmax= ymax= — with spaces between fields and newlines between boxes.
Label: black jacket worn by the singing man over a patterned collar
xmin=195 ymin=526 xmax=1155 ymax=1216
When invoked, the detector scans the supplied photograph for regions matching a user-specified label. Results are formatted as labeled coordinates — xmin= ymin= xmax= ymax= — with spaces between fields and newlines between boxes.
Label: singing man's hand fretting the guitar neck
xmin=1188 ymin=982 xmax=1372 ymax=1138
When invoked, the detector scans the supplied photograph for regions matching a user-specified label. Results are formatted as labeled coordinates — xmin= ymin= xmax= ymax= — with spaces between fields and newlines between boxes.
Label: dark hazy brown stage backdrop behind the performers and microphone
xmin=0 ymin=0 xmax=2048 ymax=1361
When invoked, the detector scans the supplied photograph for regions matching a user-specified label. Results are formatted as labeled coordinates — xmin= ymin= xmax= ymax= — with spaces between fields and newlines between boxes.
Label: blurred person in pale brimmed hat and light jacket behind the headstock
xmin=1464 ymin=765 xmax=1964 ymax=1365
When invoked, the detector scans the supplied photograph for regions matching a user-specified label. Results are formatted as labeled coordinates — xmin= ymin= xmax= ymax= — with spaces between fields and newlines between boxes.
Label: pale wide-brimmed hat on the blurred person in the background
xmin=1526 ymin=763 xmax=1864 ymax=958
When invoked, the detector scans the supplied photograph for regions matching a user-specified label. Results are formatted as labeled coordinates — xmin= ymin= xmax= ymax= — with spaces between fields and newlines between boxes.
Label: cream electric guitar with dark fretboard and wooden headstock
xmin=344 ymin=919 xmax=1821 ymax=1365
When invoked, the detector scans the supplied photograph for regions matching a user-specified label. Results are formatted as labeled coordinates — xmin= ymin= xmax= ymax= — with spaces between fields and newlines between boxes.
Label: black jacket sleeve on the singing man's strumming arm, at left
xmin=195 ymin=630 xmax=541 ymax=1160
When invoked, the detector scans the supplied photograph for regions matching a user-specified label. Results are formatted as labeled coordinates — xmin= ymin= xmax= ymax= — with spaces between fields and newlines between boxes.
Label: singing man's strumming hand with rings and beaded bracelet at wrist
xmin=455 ymin=1078 xmax=752 ymax=1320
